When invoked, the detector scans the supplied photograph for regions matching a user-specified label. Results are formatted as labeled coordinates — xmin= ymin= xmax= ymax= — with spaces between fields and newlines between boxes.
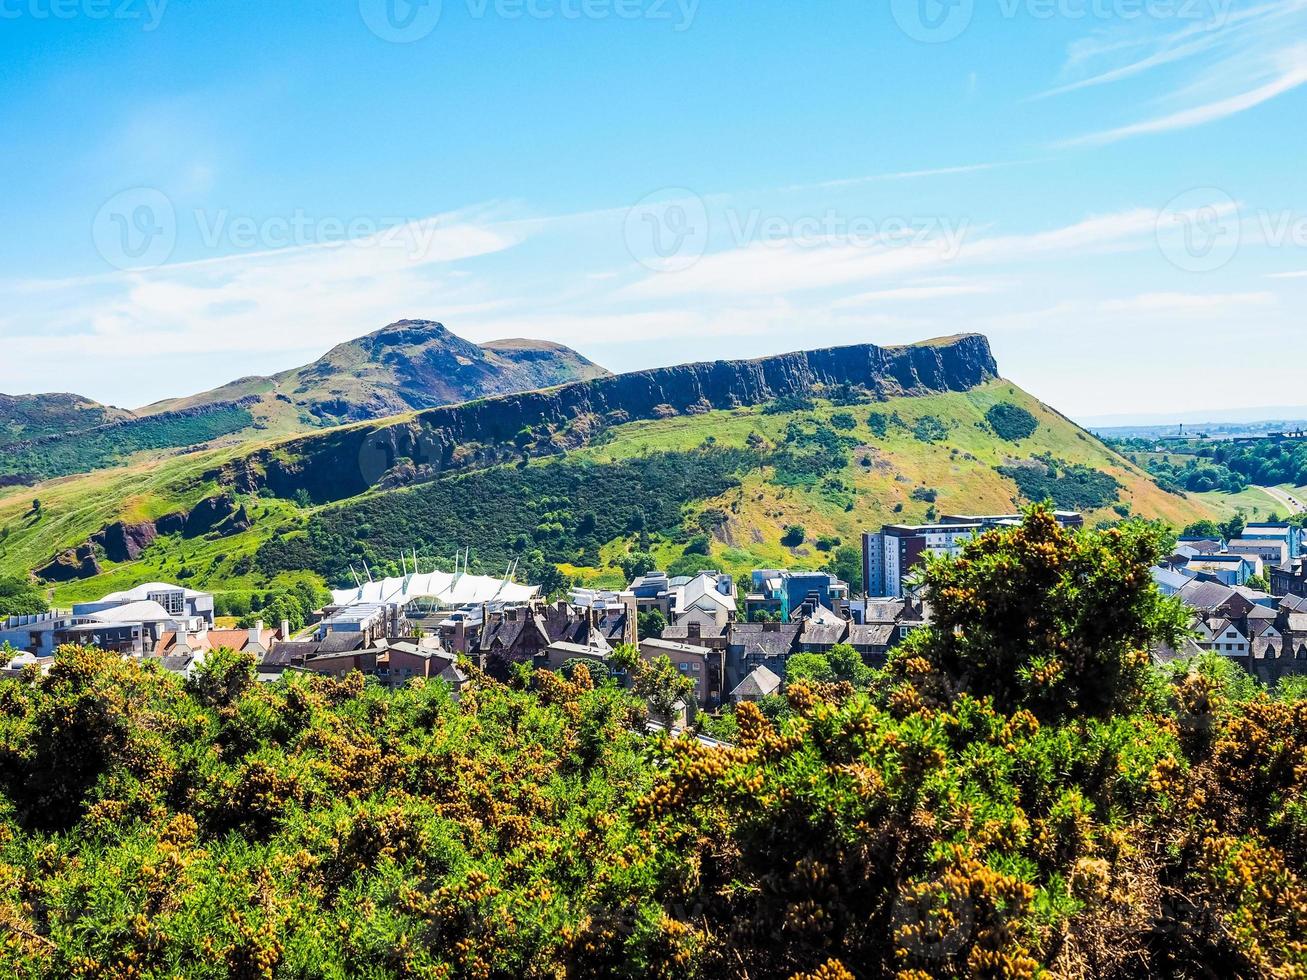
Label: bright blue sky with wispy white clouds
xmin=0 ymin=0 xmax=1307 ymax=418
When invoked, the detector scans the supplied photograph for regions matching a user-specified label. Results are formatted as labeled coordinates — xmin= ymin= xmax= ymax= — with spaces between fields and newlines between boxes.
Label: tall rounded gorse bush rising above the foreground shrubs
xmin=891 ymin=506 xmax=1188 ymax=719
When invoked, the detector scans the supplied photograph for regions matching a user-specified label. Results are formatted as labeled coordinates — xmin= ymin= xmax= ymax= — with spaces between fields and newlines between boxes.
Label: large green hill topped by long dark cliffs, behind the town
xmin=0 ymin=336 xmax=1222 ymax=601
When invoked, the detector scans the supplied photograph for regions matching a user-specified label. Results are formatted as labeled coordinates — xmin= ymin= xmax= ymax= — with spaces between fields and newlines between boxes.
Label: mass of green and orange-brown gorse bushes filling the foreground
xmin=0 ymin=508 xmax=1307 ymax=980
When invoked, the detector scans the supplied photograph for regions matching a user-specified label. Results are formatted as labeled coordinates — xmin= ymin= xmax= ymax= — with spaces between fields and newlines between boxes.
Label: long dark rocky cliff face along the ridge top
xmin=212 ymin=335 xmax=997 ymax=502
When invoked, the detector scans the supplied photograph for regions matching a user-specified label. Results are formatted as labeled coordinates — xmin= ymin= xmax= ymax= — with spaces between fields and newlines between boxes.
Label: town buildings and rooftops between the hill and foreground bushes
xmin=0 ymin=511 xmax=1307 ymax=724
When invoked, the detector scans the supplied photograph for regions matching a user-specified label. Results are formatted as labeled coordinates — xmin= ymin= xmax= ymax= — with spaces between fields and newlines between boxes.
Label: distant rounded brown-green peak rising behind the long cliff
xmin=140 ymin=320 xmax=608 ymax=431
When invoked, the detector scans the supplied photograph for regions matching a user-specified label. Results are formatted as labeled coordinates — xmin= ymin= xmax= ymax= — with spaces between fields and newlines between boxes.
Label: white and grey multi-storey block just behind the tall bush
xmin=863 ymin=511 xmax=1085 ymax=597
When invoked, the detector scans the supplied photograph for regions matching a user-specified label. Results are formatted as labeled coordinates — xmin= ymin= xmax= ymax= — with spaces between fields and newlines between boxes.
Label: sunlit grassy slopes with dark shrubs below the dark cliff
xmin=0 ymin=380 xmax=1212 ymax=602
